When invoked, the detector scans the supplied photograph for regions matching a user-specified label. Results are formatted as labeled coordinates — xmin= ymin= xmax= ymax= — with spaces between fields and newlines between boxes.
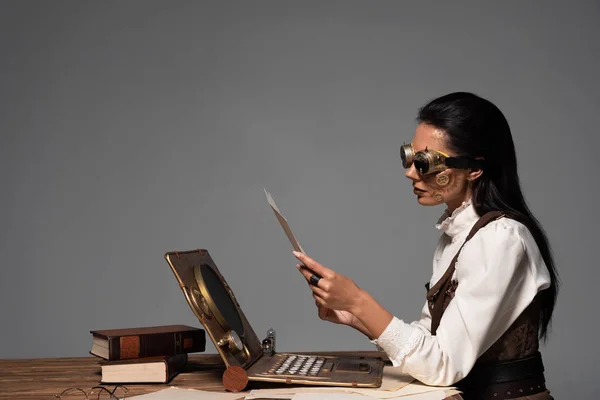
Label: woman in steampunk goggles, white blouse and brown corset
xmin=294 ymin=93 xmax=558 ymax=400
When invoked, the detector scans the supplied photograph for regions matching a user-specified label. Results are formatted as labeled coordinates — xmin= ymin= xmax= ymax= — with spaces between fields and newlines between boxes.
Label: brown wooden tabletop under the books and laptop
xmin=0 ymin=351 xmax=462 ymax=400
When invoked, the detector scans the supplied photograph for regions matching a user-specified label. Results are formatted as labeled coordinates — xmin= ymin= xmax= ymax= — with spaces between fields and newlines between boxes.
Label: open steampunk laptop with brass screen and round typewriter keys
xmin=165 ymin=250 xmax=384 ymax=387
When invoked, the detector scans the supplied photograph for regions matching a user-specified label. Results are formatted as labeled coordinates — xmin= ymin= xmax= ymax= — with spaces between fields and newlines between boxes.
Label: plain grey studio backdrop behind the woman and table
xmin=0 ymin=1 xmax=600 ymax=399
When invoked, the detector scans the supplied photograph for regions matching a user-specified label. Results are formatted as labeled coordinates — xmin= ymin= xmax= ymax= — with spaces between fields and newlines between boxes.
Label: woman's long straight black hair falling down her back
xmin=417 ymin=92 xmax=558 ymax=339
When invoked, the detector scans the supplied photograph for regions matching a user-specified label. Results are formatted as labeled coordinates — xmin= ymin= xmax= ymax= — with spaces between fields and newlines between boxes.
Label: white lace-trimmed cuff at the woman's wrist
xmin=371 ymin=317 xmax=423 ymax=367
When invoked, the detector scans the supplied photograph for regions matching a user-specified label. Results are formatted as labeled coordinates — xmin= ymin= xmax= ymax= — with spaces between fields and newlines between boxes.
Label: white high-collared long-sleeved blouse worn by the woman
xmin=372 ymin=203 xmax=550 ymax=386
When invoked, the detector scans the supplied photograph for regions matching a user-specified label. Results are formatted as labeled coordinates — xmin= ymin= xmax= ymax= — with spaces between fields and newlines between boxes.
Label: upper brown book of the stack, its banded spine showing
xmin=90 ymin=325 xmax=206 ymax=361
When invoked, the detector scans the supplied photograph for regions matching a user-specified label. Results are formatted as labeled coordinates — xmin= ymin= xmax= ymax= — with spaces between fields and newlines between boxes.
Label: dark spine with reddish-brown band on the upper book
xmin=108 ymin=329 xmax=206 ymax=361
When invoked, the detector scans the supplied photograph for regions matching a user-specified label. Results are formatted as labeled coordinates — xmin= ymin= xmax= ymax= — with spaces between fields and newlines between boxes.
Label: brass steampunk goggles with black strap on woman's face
xmin=400 ymin=144 xmax=483 ymax=175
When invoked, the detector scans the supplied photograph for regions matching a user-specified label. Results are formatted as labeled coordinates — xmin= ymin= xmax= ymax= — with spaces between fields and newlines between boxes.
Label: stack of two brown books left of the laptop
xmin=90 ymin=325 xmax=206 ymax=383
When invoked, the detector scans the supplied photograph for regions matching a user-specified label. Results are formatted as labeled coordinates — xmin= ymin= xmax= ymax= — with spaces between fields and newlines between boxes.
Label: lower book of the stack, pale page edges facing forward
xmin=100 ymin=354 xmax=187 ymax=383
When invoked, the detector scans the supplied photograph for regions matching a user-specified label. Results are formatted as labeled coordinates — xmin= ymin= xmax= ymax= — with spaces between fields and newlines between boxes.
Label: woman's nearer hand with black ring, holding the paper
xmin=294 ymin=252 xmax=362 ymax=316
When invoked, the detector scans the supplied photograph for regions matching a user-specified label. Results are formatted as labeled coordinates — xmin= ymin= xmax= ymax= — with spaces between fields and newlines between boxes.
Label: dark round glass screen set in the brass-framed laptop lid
xmin=200 ymin=264 xmax=244 ymax=335
